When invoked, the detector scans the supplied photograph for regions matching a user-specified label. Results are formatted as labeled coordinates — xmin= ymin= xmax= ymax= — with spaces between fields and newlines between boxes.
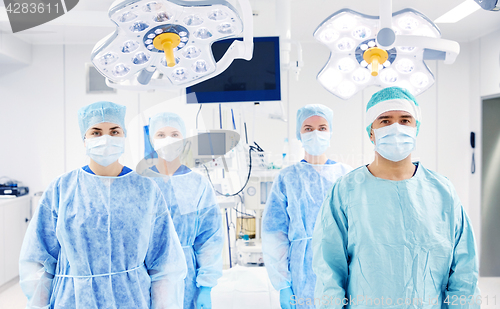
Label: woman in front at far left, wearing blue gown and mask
xmin=20 ymin=102 xmax=186 ymax=309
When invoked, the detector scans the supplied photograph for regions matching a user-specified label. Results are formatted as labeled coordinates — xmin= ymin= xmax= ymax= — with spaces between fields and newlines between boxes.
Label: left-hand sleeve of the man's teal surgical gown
xmin=312 ymin=181 xmax=349 ymax=309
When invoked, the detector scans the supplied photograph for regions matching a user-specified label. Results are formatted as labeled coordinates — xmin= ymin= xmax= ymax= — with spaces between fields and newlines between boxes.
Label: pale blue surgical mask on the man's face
xmin=373 ymin=123 xmax=417 ymax=162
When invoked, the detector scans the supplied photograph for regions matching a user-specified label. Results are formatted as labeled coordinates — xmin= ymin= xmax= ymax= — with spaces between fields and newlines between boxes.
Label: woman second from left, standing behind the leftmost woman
xmin=145 ymin=113 xmax=224 ymax=309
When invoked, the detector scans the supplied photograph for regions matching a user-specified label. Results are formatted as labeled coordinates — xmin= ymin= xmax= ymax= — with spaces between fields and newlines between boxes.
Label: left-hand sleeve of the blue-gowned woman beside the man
xmin=262 ymin=174 xmax=292 ymax=291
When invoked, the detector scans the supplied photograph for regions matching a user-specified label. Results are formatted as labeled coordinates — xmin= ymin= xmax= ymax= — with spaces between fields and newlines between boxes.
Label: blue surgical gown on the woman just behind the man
xmin=262 ymin=160 xmax=351 ymax=308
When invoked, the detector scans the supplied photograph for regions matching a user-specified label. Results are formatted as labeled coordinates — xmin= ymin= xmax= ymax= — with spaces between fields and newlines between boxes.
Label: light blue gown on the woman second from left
xmin=148 ymin=165 xmax=224 ymax=309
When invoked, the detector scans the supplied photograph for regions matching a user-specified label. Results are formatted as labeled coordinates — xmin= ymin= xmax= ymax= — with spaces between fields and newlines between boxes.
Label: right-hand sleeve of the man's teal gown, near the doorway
xmin=445 ymin=187 xmax=480 ymax=309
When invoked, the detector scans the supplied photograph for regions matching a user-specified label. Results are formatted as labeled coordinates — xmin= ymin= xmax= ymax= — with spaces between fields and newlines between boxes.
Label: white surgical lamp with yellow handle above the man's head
xmin=314 ymin=0 xmax=460 ymax=100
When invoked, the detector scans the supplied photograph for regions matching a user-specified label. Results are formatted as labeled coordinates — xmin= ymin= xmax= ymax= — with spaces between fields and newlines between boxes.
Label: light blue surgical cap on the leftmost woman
xmin=78 ymin=102 xmax=127 ymax=139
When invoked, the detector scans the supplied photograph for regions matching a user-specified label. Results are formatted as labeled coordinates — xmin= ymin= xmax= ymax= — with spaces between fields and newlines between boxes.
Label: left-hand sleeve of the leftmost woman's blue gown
xmin=19 ymin=182 xmax=61 ymax=309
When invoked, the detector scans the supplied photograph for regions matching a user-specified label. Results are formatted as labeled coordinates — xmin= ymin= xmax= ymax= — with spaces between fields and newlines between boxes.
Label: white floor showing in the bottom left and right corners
xmin=0 ymin=277 xmax=500 ymax=309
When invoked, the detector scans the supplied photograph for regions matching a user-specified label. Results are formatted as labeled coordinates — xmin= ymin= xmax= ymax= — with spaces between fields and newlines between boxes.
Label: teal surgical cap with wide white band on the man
xmin=365 ymin=87 xmax=421 ymax=136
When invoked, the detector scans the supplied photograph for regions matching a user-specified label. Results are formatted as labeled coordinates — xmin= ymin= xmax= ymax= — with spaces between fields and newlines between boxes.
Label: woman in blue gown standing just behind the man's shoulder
xmin=262 ymin=104 xmax=352 ymax=309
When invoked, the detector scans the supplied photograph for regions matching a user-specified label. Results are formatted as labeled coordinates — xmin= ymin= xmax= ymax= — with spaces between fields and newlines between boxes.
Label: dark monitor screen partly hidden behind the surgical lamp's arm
xmin=186 ymin=37 xmax=281 ymax=103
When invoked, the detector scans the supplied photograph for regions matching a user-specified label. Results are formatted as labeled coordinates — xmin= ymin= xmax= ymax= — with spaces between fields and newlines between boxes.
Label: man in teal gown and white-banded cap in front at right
xmin=313 ymin=87 xmax=480 ymax=309
